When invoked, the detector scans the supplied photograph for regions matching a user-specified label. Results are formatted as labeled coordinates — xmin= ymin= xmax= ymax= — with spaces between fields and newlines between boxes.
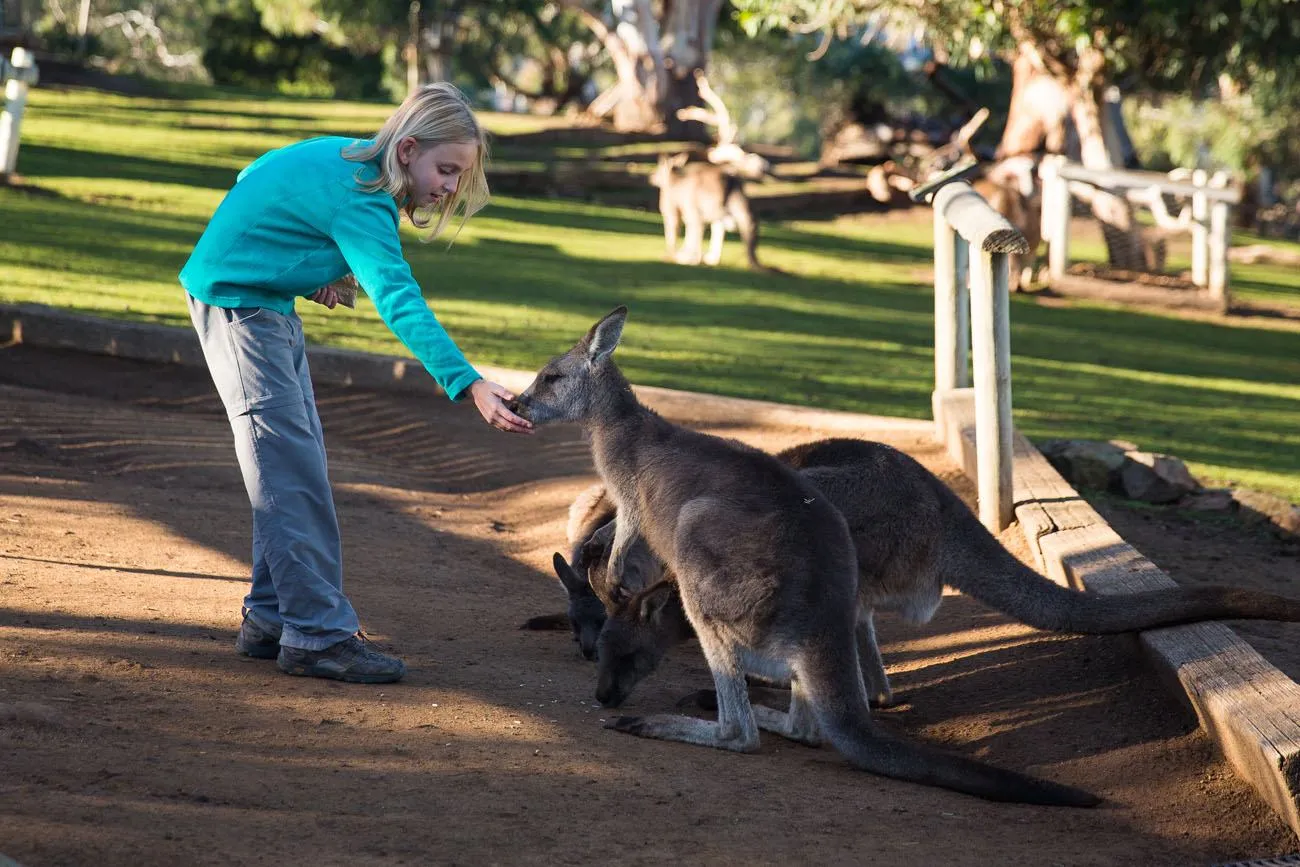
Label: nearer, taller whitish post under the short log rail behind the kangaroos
xmin=971 ymin=251 xmax=1014 ymax=533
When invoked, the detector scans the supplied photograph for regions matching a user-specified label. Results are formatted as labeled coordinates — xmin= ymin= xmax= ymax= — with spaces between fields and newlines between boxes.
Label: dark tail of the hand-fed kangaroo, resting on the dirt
xmin=800 ymin=660 xmax=1101 ymax=807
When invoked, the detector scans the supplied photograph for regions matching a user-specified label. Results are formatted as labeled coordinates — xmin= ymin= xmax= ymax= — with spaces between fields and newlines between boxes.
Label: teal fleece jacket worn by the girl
xmin=181 ymin=136 xmax=480 ymax=400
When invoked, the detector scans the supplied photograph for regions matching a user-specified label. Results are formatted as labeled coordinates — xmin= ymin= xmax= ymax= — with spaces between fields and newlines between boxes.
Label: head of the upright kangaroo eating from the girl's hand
xmin=511 ymin=307 xmax=628 ymax=425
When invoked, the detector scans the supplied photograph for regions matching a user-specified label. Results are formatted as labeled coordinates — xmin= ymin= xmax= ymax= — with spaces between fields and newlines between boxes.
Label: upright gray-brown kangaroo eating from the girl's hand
xmin=515 ymin=307 xmax=1099 ymax=806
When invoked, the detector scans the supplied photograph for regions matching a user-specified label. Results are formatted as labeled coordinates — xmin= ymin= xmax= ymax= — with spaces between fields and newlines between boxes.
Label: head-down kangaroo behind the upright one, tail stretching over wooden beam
xmin=561 ymin=439 xmax=1300 ymax=706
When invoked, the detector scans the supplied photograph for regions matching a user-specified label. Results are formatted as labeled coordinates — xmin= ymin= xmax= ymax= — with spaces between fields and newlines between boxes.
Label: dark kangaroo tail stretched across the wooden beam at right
xmin=939 ymin=506 xmax=1300 ymax=633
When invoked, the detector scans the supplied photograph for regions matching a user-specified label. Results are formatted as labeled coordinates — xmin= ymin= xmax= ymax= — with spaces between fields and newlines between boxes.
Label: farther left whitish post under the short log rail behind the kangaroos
xmin=931 ymin=211 xmax=970 ymax=438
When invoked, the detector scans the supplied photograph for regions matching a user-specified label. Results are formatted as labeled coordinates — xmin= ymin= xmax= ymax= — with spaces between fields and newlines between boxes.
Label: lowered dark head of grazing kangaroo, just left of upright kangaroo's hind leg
xmin=595 ymin=581 xmax=692 ymax=707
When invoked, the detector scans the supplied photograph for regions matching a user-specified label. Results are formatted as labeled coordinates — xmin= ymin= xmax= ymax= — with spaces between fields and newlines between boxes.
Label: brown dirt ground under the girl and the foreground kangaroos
xmin=0 ymin=347 xmax=1300 ymax=867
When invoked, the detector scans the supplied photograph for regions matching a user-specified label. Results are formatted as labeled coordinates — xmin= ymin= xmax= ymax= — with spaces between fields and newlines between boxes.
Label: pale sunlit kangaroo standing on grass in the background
xmin=650 ymin=153 xmax=774 ymax=270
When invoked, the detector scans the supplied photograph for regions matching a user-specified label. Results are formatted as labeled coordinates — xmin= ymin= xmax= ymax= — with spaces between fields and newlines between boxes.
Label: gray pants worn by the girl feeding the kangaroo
xmin=190 ymin=296 xmax=359 ymax=650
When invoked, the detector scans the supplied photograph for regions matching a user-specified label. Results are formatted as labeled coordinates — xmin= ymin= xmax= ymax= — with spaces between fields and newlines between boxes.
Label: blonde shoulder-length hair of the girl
xmin=343 ymin=82 xmax=488 ymax=240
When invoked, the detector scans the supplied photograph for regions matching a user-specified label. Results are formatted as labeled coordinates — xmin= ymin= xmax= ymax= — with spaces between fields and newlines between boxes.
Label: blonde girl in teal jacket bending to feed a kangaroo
xmin=181 ymin=83 xmax=532 ymax=684
